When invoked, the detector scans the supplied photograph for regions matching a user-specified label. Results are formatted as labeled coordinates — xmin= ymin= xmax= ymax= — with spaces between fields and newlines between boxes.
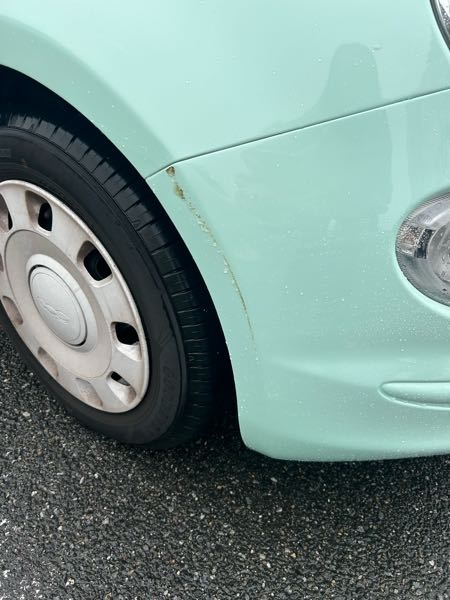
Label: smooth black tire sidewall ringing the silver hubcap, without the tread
xmin=0 ymin=128 xmax=186 ymax=444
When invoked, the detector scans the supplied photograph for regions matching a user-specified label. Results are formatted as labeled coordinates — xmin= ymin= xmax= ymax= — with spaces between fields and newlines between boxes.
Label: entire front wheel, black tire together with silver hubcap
xmin=0 ymin=95 xmax=223 ymax=447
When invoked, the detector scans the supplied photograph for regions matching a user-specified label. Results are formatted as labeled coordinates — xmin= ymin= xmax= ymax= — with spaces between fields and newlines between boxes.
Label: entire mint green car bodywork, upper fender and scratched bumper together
xmin=0 ymin=0 xmax=450 ymax=460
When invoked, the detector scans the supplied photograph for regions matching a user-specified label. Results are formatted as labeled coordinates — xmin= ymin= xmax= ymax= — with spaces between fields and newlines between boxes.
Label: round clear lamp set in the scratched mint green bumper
xmin=396 ymin=195 xmax=450 ymax=305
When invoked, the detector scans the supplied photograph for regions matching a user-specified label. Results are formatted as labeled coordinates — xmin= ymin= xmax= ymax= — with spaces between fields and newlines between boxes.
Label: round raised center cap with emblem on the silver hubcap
xmin=29 ymin=267 xmax=87 ymax=346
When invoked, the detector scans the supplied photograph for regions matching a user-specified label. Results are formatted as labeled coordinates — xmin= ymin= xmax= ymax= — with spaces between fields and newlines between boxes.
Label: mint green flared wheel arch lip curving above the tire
xmin=0 ymin=15 xmax=172 ymax=177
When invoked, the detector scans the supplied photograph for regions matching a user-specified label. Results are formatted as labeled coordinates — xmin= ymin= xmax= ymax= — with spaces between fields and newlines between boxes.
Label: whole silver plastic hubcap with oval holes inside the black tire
xmin=0 ymin=181 xmax=149 ymax=413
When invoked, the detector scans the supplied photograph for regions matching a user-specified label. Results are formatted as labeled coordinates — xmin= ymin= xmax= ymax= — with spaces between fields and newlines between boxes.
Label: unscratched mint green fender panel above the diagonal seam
xmin=0 ymin=0 xmax=450 ymax=176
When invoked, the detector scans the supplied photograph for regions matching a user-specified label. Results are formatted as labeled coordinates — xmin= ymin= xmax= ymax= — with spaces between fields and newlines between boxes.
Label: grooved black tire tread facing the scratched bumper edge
xmin=0 ymin=88 xmax=228 ymax=448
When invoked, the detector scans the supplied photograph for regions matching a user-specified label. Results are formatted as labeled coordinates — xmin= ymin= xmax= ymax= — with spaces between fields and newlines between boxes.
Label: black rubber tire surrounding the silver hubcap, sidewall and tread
xmin=0 ymin=81 xmax=227 ymax=448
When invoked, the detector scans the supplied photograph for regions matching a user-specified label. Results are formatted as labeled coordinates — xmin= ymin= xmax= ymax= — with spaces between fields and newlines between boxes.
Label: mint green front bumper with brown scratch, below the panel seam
xmin=149 ymin=92 xmax=450 ymax=460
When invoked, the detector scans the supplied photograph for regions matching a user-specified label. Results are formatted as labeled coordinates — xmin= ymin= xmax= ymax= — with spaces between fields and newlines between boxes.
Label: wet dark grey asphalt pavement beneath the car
xmin=0 ymin=332 xmax=450 ymax=600
